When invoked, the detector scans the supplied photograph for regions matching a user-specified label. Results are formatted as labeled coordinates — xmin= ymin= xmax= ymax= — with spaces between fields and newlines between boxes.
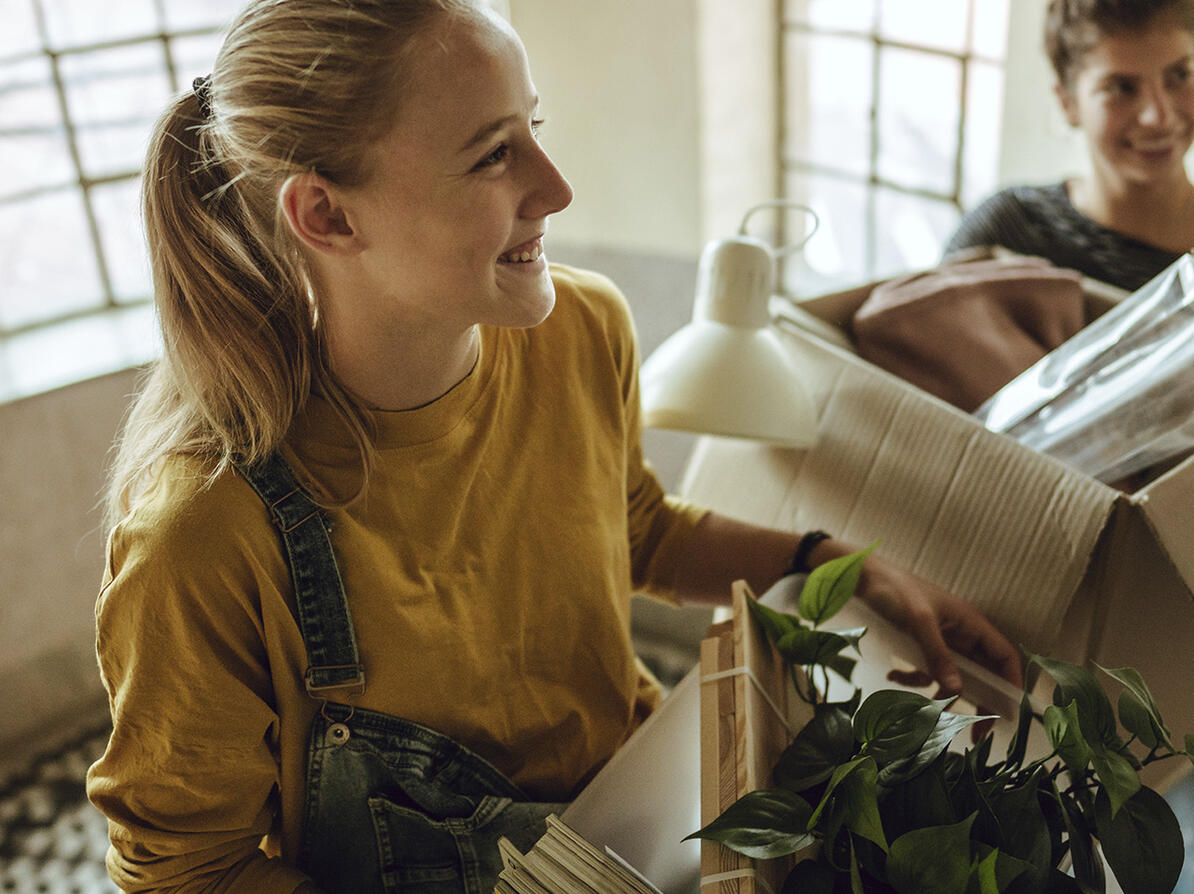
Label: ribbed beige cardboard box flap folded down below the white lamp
xmin=685 ymin=329 xmax=1119 ymax=651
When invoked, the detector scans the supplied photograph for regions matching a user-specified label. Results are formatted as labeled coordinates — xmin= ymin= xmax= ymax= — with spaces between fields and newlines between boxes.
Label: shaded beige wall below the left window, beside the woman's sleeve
xmin=0 ymin=371 xmax=135 ymax=749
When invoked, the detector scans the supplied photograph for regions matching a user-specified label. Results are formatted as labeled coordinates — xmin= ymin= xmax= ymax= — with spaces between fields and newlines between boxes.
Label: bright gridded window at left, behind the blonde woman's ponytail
xmin=0 ymin=0 xmax=240 ymax=394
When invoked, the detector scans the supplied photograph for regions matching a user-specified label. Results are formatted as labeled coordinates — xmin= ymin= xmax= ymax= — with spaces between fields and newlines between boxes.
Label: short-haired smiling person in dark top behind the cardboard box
xmin=946 ymin=0 xmax=1194 ymax=290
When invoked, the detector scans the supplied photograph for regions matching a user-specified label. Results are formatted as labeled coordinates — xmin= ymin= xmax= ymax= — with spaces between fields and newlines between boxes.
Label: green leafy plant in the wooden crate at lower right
xmin=689 ymin=547 xmax=1194 ymax=894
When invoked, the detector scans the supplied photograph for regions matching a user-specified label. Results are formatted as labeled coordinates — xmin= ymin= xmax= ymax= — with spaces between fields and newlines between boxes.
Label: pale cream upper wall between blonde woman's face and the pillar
xmin=509 ymin=0 xmax=701 ymax=258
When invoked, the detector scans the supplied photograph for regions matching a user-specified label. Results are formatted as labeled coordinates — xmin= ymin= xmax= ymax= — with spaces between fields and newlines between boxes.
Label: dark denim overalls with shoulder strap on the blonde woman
xmin=238 ymin=455 xmax=566 ymax=894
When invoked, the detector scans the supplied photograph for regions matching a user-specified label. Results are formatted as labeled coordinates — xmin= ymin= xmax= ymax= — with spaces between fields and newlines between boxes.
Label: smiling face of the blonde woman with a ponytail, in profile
xmin=341 ymin=16 xmax=572 ymax=328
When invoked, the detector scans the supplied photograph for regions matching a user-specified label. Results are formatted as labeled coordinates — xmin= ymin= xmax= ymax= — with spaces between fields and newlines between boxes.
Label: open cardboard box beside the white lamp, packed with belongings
xmin=682 ymin=263 xmax=1194 ymax=784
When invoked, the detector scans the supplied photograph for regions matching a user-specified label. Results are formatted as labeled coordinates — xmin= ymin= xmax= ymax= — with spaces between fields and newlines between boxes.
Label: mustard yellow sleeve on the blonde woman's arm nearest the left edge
xmin=87 ymin=489 xmax=306 ymax=894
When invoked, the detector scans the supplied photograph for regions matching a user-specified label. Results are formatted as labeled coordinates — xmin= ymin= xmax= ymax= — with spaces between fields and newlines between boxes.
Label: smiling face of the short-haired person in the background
xmin=1058 ymin=18 xmax=1194 ymax=185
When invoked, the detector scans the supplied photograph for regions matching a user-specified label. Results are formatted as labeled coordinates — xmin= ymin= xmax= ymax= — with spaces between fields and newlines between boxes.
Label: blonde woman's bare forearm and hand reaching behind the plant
xmin=676 ymin=513 xmax=1023 ymax=693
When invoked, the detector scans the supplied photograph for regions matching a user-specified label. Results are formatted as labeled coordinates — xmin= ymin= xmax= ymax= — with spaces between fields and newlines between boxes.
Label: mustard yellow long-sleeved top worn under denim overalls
xmin=88 ymin=267 xmax=702 ymax=892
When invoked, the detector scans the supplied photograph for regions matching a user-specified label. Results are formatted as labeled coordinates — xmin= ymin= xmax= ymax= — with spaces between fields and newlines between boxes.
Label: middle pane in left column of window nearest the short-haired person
xmin=784 ymin=33 xmax=874 ymax=177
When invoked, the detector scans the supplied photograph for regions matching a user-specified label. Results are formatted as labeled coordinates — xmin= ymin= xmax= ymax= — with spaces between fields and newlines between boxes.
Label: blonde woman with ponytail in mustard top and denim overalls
xmin=88 ymin=0 xmax=1020 ymax=894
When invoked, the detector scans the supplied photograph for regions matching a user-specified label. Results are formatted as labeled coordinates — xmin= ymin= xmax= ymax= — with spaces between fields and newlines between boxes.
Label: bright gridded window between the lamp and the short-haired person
xmin=778 ymin=0 xmax=1009 ymax=296
